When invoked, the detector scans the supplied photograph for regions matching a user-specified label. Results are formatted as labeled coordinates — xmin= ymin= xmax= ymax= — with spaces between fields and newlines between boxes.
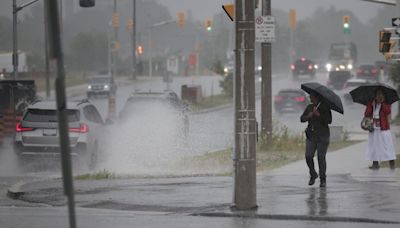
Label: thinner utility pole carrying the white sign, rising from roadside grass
xmin=261 ymin=0 xmax=272 ymax=145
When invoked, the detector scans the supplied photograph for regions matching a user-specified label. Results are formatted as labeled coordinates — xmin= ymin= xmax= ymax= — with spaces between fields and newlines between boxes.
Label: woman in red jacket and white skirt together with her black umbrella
xmin=350 ymin=83 xmax=399 ymax=170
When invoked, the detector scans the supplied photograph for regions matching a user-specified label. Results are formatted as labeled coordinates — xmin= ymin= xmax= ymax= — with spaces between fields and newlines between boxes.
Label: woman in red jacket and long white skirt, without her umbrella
xmin=364 ymin=90 xmax=396 ymax=169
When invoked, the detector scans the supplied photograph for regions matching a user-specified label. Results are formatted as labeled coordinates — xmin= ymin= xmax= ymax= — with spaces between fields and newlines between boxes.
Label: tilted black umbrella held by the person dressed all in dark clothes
xmin=301 ymin=82 xmax=343 ymax=114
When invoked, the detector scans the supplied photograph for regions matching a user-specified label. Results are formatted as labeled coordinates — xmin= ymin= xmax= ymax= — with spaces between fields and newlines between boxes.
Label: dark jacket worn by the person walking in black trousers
xmin=300 ymin=103 xmax=332 ymax=140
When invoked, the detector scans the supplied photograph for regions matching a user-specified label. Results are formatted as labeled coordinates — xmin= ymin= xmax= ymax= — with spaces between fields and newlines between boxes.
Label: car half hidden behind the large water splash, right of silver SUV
xmin=119 ymin=90 xmax=189 ymax=137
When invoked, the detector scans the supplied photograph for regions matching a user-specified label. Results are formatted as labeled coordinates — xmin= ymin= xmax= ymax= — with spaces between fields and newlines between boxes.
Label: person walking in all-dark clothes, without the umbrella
xmin=300 ymin=94 xmax=332 ymax=187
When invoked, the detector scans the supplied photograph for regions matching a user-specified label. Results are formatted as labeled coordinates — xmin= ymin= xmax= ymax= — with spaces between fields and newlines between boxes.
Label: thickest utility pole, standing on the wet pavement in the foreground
xmin=233 ymin=0 xmax=257 ymax=210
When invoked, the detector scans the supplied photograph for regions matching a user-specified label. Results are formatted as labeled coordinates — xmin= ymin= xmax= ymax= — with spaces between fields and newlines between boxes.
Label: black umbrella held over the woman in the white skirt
xmin=350 ymin=83 xmax=400 ymax=105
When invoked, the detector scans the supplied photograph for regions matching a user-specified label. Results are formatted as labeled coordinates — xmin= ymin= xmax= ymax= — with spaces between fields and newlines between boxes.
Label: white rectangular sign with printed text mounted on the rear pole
xmin=254 ymin=16 xmax=275 ymax=43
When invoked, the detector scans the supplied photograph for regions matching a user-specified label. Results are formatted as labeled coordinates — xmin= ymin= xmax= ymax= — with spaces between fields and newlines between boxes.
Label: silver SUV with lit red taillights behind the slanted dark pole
xmin=14 ymin=100 xmax=105 ymax=168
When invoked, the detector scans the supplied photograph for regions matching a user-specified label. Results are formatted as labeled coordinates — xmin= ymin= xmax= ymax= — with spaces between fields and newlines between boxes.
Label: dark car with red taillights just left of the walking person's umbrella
xmin=274 ymin=89 xmax=309 ymax=113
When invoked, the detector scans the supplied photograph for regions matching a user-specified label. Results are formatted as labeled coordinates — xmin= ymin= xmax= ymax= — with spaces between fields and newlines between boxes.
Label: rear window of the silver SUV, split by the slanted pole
xmin=24 ymin=109 xmax=80 ymax=123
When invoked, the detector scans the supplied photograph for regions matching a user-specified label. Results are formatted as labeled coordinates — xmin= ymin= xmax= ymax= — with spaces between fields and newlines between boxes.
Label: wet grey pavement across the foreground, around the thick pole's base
xmin=5 ymin=125 xmax=400 ymax=227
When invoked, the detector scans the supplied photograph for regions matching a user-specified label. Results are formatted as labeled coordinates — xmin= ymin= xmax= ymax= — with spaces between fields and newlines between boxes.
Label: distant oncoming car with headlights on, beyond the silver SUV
xmin=86 ymin=75 xmax=117 ymax=99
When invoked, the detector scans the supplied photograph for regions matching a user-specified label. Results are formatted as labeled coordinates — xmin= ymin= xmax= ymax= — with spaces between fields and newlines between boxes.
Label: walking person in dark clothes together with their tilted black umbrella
xmin=300 ymin=82 xmax=343 ymax=187
